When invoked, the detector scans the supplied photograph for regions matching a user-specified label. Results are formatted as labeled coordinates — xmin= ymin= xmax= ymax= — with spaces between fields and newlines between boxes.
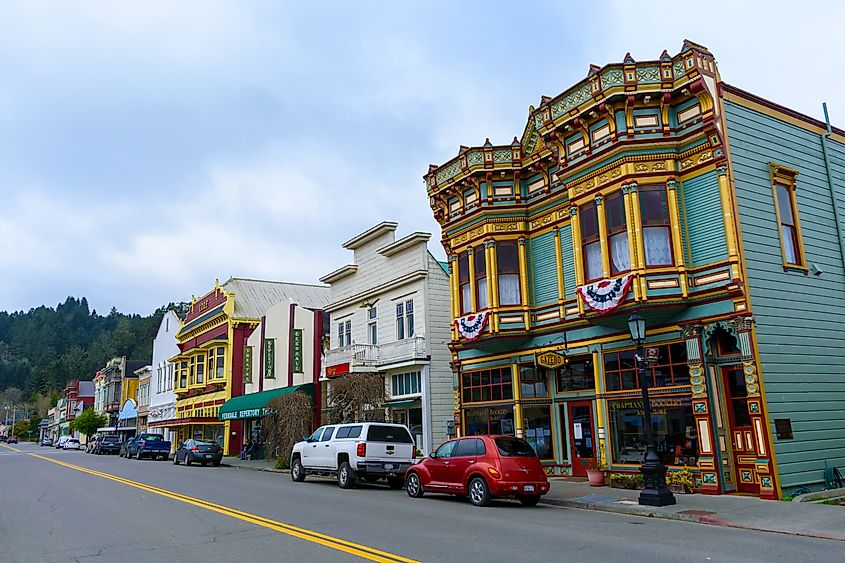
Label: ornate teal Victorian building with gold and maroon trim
xmin=425 ymin=41 xmax=845 ymax=498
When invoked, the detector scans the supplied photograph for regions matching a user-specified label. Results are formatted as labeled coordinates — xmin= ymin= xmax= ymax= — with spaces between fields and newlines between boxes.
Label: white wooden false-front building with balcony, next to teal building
xmin=320 ymin=221 xmax=454 ymax=453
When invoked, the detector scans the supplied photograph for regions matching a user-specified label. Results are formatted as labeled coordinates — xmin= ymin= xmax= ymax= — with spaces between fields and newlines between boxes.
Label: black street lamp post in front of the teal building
xmin=628 ymin=313 xmax=675 ymax=506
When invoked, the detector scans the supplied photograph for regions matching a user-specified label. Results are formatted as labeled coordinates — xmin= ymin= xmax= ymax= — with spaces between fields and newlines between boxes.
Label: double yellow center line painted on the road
xmin=24 ymin=452 xmax=418 ymax=563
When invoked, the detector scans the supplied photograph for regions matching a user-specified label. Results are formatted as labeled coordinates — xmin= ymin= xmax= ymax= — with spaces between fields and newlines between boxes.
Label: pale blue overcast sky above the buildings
xmin=0 ymin=0 xmax=845 ymax=314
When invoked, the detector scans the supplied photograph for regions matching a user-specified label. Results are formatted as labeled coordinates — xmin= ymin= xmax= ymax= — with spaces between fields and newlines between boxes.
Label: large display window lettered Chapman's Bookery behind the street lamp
xmin=607 ymin=397 xmax=698 ymax=465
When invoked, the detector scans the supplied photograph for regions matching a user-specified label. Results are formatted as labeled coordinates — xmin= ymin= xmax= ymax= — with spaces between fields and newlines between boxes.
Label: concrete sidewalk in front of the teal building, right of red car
xmin=541 ymin=478 xmax=845 ymax=541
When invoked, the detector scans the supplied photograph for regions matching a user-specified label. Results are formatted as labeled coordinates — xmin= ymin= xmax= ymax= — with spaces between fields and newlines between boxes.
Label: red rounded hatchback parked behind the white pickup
xmin=405 ymin=436 xmax=549 ymax=506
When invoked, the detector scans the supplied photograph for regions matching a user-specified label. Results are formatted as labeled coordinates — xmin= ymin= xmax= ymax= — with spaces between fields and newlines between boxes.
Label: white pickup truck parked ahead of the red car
xmin=290 ymin=422 xmax=416 ymax=489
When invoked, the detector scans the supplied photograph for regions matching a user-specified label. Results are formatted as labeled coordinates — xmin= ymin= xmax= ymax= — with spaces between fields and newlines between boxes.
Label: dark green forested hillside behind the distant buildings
xmin=0 ymin=297 xmax=183 ymax=396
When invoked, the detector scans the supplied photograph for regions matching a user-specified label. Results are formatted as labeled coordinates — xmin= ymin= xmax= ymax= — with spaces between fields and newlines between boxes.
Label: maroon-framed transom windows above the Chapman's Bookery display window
xmin=604 ymin=342 xmax=689 ymax=391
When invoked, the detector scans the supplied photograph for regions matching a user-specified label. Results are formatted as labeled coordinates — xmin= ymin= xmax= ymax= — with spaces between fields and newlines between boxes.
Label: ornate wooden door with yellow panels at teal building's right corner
xmin=722 ymin=367 xmax=760 ymax=493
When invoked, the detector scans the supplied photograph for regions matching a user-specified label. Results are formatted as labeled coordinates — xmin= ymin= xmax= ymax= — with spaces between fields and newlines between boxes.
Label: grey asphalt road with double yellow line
xmin=0 ymin=444 xmax=845 ymax=563
